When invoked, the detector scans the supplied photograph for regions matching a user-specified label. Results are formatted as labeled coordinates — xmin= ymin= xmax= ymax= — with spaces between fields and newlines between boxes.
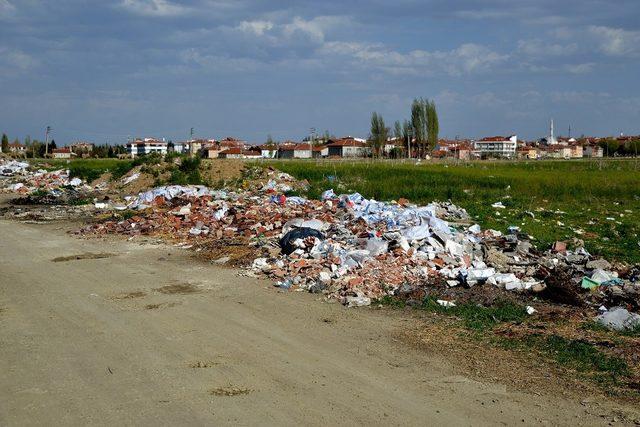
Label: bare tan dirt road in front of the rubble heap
xmin=0 ymin=221 xmax=636 ymax=426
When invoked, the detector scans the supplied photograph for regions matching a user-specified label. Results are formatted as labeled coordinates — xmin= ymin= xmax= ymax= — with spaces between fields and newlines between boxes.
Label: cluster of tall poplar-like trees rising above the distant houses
xmin=369 ymin=98 xmax=440 ymax=158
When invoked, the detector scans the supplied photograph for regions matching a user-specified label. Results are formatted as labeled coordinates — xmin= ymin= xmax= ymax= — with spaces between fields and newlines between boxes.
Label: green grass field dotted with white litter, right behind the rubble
xmin=268 ymin=160 xmax=640 ymax=263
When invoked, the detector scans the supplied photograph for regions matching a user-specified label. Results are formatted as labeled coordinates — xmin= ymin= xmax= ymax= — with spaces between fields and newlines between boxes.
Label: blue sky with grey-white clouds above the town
xmin=0 ymin=0 xmax=640 ymax=143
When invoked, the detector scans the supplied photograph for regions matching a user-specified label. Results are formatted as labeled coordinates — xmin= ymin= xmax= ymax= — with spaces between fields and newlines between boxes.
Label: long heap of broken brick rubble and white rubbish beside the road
xmin=2 ymin=160 xmax=640 ymax=329
